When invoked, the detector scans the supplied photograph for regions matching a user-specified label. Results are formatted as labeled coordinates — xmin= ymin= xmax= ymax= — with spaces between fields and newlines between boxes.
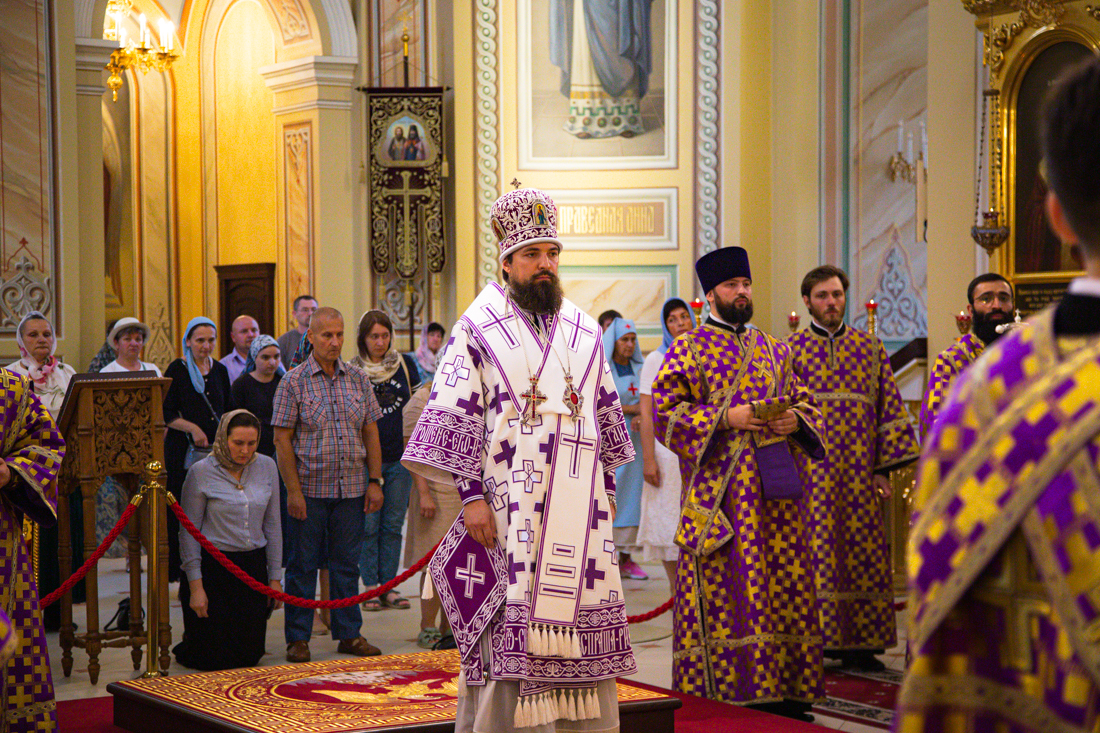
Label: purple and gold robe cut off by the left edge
xmin=0 ymin=370 xmax=65 ymax=733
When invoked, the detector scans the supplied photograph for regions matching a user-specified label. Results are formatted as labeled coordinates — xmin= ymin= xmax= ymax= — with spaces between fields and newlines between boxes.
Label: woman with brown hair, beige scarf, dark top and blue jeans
xmin=351 ymin=310 xmax=420 ymax=611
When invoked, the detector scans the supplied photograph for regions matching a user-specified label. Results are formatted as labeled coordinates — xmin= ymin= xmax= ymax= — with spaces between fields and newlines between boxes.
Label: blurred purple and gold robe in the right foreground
xmin=895 ymin=309 xmax=1100 ymax=732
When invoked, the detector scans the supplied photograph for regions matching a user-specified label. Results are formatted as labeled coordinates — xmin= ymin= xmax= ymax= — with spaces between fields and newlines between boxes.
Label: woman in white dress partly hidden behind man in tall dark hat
xmin=638 ymin=298 xmax=695 ymax=588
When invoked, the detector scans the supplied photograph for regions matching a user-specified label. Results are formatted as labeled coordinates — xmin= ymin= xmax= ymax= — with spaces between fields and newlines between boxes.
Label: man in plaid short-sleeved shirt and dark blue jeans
xmin=272 ymin=308 xmax=383 ymax=661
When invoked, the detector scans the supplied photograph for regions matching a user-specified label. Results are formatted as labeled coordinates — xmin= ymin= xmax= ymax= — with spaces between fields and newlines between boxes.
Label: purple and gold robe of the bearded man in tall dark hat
xmin=652 ymin=321 xmax=823 ymax=703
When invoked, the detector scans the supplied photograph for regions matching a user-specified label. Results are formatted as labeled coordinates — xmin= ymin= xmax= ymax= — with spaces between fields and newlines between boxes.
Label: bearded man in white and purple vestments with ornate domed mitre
xmin=403 ymin=188 xmax=636 ymax=733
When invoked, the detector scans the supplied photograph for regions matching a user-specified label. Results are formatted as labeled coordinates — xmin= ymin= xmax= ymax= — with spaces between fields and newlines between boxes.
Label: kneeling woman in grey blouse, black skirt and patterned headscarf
xmin=173 ymin=409 xmax=283 ymax=670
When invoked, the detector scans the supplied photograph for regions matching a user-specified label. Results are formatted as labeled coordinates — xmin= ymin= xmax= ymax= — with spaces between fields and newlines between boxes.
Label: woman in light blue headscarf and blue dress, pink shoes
xmin=603 ymin=318 xmax=649 ymax=580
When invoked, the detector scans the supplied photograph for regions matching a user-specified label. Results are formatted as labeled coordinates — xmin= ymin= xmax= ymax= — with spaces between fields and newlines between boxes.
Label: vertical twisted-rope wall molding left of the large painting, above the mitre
xmin=474 ymin=0 xmax=501 ymax=289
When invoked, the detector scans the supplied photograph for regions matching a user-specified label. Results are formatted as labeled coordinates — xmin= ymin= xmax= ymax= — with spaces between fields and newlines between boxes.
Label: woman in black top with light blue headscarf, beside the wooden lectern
xmin=164 ymin=316 xmax=233 ymax=582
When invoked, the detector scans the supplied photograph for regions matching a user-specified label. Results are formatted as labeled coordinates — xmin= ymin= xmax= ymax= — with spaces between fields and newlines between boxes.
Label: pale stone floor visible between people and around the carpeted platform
xmin=47 ymin=559 xmax=904 ymax=733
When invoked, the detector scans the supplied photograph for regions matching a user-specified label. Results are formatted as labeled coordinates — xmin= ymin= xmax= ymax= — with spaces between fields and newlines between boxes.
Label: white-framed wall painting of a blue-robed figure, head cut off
xmin=517 ymin=0 xmax=677 ymax=171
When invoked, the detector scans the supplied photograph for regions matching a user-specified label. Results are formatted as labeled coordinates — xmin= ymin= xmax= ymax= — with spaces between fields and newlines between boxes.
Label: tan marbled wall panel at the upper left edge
xmin=0 ymin=0 xmax=61 ymax=333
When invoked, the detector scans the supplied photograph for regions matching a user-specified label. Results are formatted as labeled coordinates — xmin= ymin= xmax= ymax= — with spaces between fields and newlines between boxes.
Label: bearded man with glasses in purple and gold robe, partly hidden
xmin=921 ymin=272 xmax=1014 ymax=438
